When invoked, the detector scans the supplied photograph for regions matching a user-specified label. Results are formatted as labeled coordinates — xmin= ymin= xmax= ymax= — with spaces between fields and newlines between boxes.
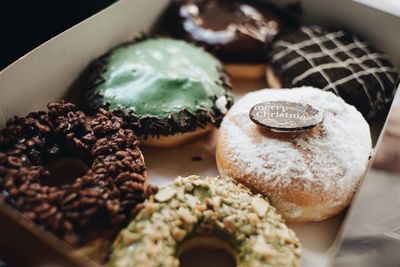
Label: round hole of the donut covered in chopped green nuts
xmin=178 ymin=237 xmax=237 ymax=267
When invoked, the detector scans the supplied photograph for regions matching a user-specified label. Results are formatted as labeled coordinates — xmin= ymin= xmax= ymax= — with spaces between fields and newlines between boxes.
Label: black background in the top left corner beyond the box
xmin=0 ymin=0 xmax=117 ymax=70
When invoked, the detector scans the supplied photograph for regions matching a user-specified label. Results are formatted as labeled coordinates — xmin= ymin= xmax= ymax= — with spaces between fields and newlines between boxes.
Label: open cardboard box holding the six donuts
xmin=0 ymin=0 xmax=400 ymax=266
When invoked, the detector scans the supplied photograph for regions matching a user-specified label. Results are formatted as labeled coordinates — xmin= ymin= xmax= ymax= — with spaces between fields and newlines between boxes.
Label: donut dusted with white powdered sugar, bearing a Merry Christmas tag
xmin=216 ymin=87 xmax=371 ymax=222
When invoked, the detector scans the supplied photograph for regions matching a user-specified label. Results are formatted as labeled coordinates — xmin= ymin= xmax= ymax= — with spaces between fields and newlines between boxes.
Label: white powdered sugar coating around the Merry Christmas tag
xmin=220 ymin=87 xmax=372 ymax=222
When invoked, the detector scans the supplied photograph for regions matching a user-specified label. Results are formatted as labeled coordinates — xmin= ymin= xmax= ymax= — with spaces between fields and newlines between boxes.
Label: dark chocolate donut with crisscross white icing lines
xmin=267 ymin=26 xmax=398 ymax=120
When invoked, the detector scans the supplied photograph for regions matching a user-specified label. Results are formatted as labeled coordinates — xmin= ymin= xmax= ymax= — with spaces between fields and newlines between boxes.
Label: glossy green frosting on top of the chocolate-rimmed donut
xmin=93 ymin=38 xmax=228 ymax=118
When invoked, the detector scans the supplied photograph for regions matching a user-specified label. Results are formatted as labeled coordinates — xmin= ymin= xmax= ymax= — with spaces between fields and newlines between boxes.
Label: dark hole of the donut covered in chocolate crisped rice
xmin=41 ymin=158 xmax=89 ymax=187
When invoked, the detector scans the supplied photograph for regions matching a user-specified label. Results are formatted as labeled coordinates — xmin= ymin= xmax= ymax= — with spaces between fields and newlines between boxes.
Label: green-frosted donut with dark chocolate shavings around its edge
xmin=87 ymin=38 xmax=233 ymax=147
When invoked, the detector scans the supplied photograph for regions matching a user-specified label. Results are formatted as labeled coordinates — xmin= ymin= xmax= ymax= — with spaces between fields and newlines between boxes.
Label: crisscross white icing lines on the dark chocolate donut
xmin=271 ymin=26 xmax=397 ymax=116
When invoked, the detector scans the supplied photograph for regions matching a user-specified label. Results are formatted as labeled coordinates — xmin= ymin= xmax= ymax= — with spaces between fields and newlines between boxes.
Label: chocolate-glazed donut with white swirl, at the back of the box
xmin=171 ymin=0 xmax=290 ymax=79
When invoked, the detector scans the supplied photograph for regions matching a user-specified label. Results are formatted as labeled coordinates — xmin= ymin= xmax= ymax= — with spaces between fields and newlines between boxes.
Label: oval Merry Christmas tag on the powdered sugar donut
xmin=250 ymin=101 xmax=324 ymax=132
